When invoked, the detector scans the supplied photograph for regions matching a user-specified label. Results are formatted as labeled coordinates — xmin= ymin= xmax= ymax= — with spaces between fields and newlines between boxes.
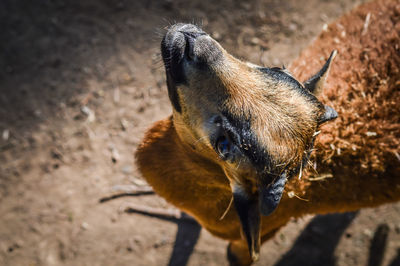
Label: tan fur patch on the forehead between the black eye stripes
xmin=214 ymin=51 xmax=319 ymax=168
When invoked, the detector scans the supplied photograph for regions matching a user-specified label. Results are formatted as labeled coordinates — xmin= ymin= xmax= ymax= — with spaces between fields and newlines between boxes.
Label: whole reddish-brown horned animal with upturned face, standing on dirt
xmin=136 ymin=1 xmax=400 ymax=265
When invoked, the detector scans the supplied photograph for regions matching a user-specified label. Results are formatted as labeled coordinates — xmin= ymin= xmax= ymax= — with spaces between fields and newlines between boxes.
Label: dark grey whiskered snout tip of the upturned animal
xmin=161 ymin=24 xmax=222 ymax=84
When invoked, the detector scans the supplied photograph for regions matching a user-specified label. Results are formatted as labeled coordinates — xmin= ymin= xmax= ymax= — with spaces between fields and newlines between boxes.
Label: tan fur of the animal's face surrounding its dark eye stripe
xmin=174 ymin=47 xmax=320 ymax=183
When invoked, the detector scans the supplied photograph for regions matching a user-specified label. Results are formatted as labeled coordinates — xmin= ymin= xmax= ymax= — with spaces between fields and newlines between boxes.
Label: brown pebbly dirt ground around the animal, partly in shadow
xmin=0 ymin=0 xmax=400 ymax=266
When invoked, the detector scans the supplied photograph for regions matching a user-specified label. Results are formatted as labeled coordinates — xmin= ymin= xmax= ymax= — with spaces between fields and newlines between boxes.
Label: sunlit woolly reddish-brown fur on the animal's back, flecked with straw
xmin=290 ymin=1 xmax=400 ymax=177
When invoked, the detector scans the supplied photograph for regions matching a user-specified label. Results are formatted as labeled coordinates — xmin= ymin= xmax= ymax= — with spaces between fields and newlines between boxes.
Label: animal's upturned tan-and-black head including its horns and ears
xmin=161 ymin=24 xmax=337 ymax=259
